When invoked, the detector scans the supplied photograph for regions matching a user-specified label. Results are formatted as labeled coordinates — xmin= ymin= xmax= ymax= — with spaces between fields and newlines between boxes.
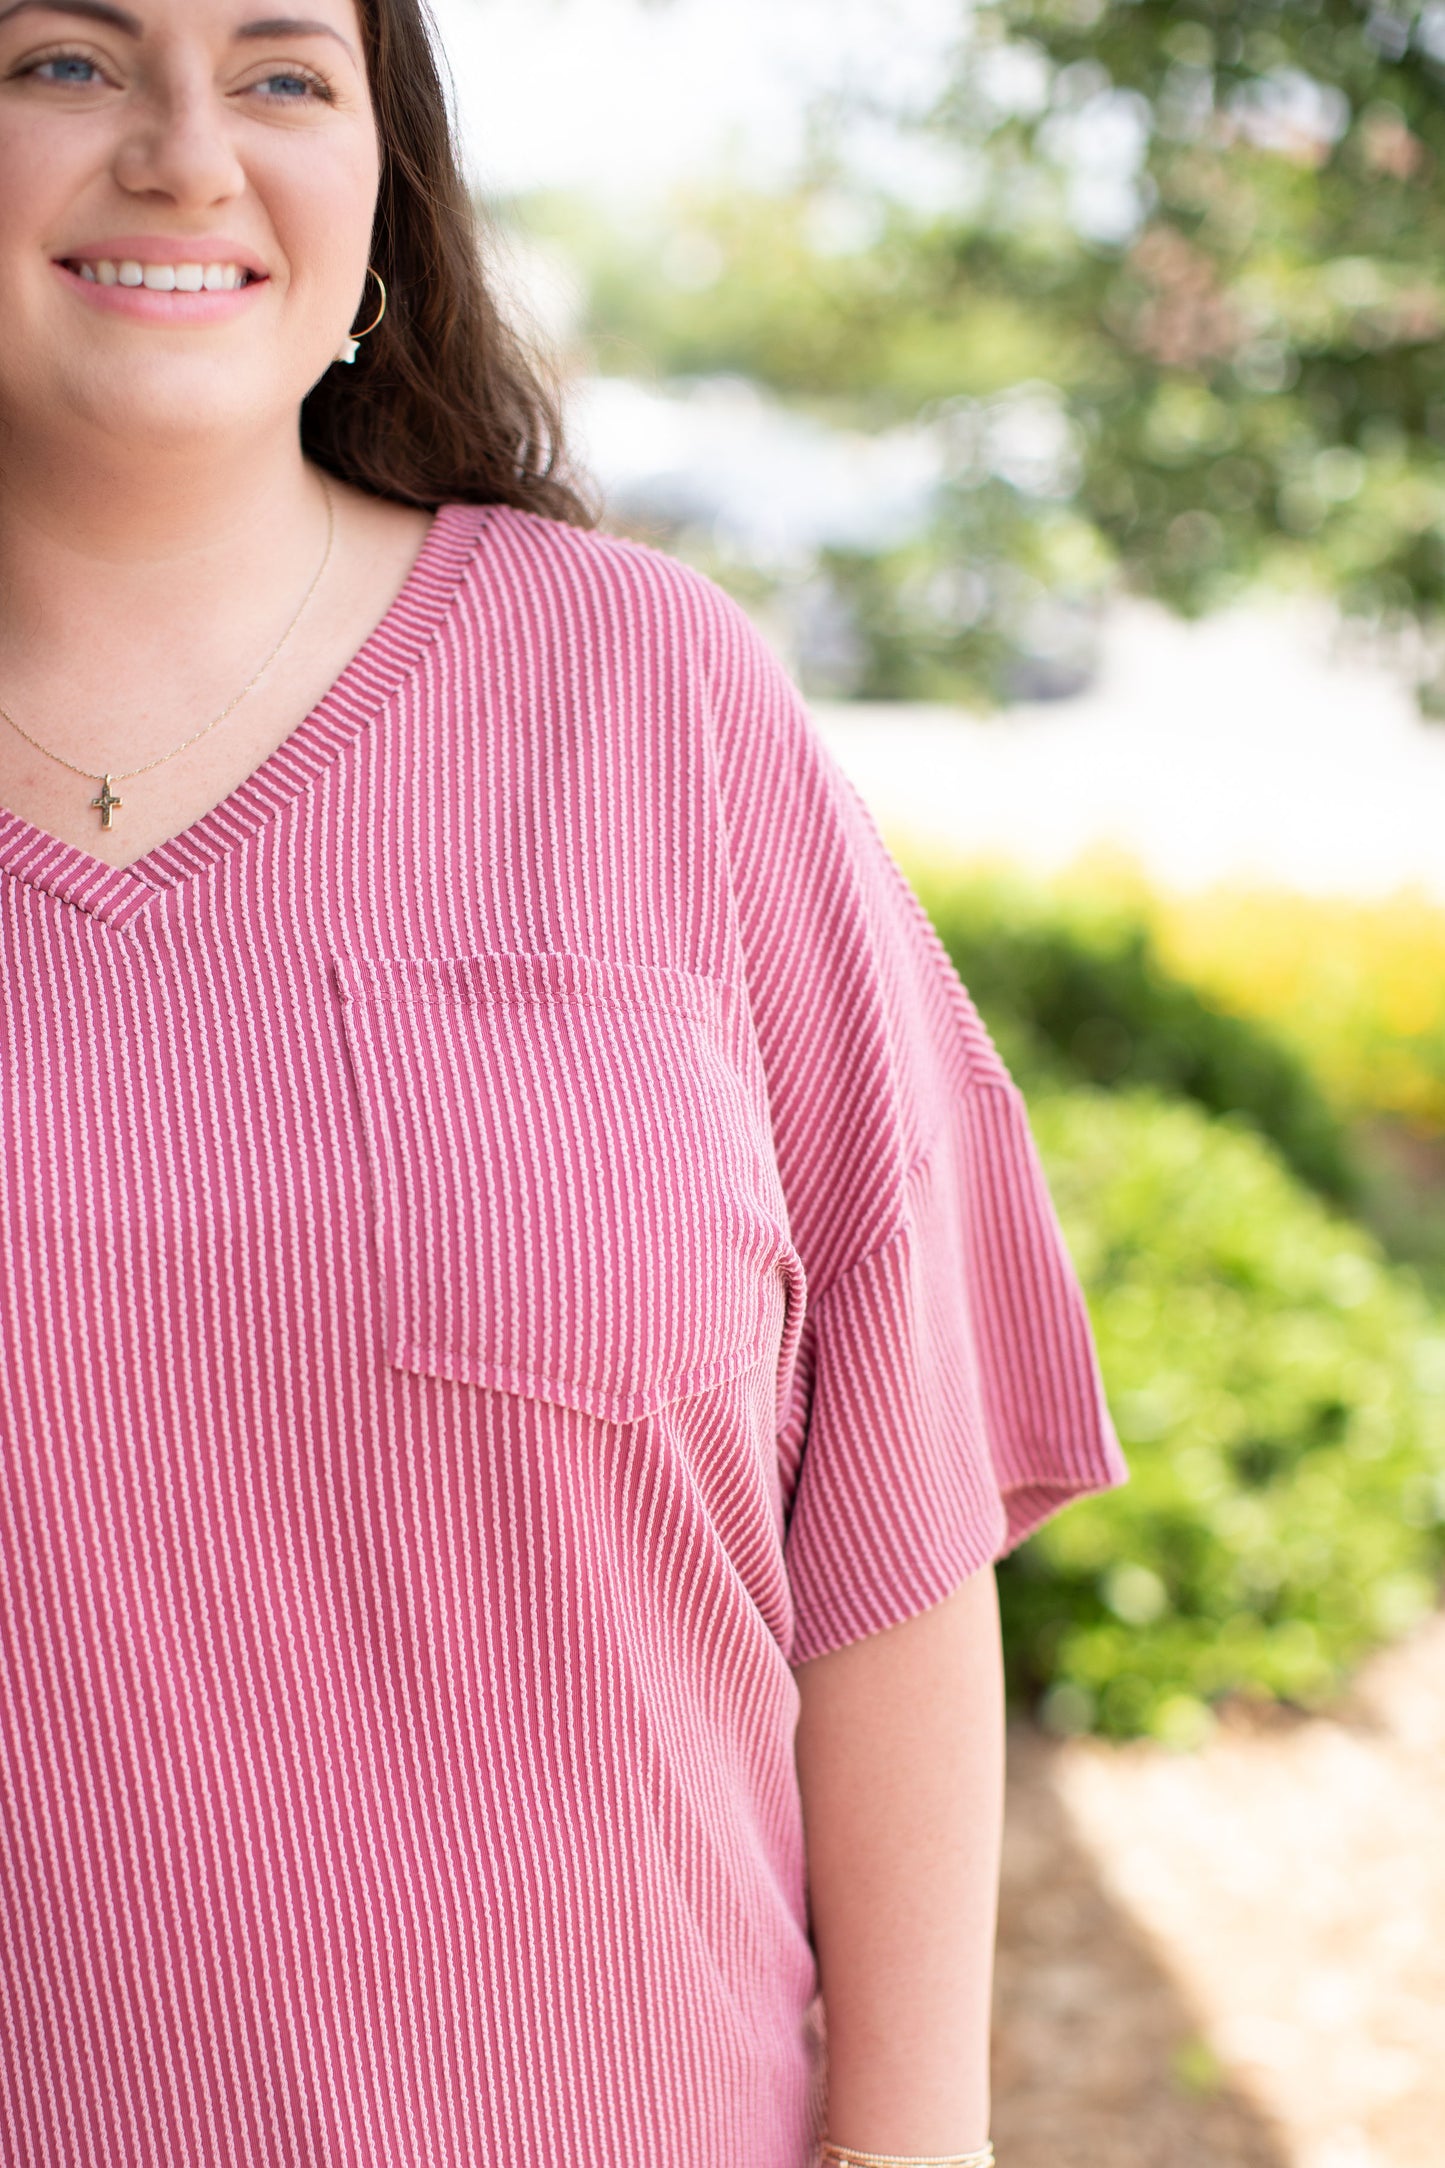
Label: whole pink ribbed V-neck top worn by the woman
xmin=0 ymin=505 xmax=1127 ymax=2168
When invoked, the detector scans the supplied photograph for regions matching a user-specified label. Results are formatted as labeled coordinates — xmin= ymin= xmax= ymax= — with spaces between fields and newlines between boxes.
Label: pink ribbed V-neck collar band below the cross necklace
xmin=0 ymin=503 xmax=492 ymax=926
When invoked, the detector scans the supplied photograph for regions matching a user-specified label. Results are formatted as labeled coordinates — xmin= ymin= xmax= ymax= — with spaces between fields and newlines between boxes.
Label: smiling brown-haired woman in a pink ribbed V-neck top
xmin=0 ymin=0 xmax=1127 ymax=2168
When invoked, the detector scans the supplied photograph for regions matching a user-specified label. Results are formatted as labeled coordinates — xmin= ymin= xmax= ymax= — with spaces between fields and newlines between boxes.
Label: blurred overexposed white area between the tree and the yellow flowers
xmin=815 ymin=603 xmax=1445 ymax=902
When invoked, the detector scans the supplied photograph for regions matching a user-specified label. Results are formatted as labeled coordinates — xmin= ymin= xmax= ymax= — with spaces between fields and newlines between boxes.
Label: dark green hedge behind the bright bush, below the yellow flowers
xmin=912 ymin=869 xmax=1358 ymax=1203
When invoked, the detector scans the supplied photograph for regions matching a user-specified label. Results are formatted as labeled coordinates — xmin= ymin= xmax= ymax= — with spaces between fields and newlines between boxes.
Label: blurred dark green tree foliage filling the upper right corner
xmin=970 ymin=0 xmax=1445 ymax=685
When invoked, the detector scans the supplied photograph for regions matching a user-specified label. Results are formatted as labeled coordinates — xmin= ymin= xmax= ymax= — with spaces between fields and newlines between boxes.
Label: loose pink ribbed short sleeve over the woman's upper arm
xmin=704 ymin=572 xmax=1129 ymax=1663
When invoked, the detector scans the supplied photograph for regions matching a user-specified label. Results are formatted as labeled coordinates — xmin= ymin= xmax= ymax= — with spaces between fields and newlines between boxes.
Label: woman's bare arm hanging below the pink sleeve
xmin=795 ymin=1565 xmax=1005 ymax=2155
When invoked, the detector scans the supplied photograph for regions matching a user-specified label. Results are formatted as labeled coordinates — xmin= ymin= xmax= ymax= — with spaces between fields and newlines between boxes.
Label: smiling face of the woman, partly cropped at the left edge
xmin=0 ymin=0 xmax=379 ymax=464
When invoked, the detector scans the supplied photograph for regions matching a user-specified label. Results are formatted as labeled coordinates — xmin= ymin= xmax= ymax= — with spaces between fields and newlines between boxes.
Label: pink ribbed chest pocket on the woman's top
xmin=331 ymin=952 xmax=802 ymax=1422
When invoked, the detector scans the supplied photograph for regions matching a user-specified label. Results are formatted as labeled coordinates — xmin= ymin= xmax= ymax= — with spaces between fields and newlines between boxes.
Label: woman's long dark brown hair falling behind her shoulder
xmin=301 ymin=0 xmax=596 ymax=527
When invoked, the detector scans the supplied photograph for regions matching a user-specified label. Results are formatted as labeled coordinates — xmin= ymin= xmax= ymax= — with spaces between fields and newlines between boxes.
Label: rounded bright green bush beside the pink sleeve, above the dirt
xmin=999 ymin=1088 xmax=1445 ymax=1745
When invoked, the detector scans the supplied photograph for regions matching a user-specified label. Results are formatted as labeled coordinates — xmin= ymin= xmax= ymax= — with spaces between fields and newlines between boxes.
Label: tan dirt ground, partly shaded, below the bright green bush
xmin=992 ymin=1611 xmax=1445 ymax=2168
